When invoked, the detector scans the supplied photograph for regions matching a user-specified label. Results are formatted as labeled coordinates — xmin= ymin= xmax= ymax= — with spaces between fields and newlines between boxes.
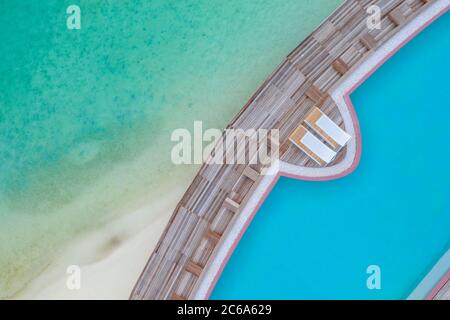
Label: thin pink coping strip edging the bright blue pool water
xmin=204 ymin=4 xmax=450 ymax=299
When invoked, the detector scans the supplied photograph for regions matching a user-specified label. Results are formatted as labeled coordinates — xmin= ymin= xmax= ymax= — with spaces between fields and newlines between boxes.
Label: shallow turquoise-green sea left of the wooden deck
xmin=0 ymin=0 xmax=342 ymax=298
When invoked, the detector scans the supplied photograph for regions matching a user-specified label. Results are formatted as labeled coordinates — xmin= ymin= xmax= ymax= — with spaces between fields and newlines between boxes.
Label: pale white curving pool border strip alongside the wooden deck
xmin=193 ymin=0 xmax=450 ymax=300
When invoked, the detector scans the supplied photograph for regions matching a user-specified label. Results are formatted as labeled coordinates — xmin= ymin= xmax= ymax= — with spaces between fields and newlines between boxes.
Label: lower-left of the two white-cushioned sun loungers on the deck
xmin=289 ymin=125 xmax=336 ymax=166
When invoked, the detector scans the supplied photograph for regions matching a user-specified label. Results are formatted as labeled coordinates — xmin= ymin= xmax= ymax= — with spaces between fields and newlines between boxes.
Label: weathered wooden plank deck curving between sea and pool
xmin=130 ymin=0 xmax=434 ymax=299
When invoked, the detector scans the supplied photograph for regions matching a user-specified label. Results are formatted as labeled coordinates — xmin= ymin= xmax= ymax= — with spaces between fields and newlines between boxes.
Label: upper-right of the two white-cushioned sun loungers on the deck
xmin=305 ymin=107 xmax=351 ymax=150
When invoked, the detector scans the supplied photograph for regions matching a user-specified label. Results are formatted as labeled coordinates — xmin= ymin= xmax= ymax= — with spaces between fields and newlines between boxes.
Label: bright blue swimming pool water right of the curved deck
xmin=211 ymin=13 xmax=450 ymax=299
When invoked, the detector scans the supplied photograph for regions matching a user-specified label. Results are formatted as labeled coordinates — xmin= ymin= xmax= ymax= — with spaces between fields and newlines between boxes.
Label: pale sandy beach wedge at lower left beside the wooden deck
xmin=15 ymin=180 xmax=186 ymax=299
